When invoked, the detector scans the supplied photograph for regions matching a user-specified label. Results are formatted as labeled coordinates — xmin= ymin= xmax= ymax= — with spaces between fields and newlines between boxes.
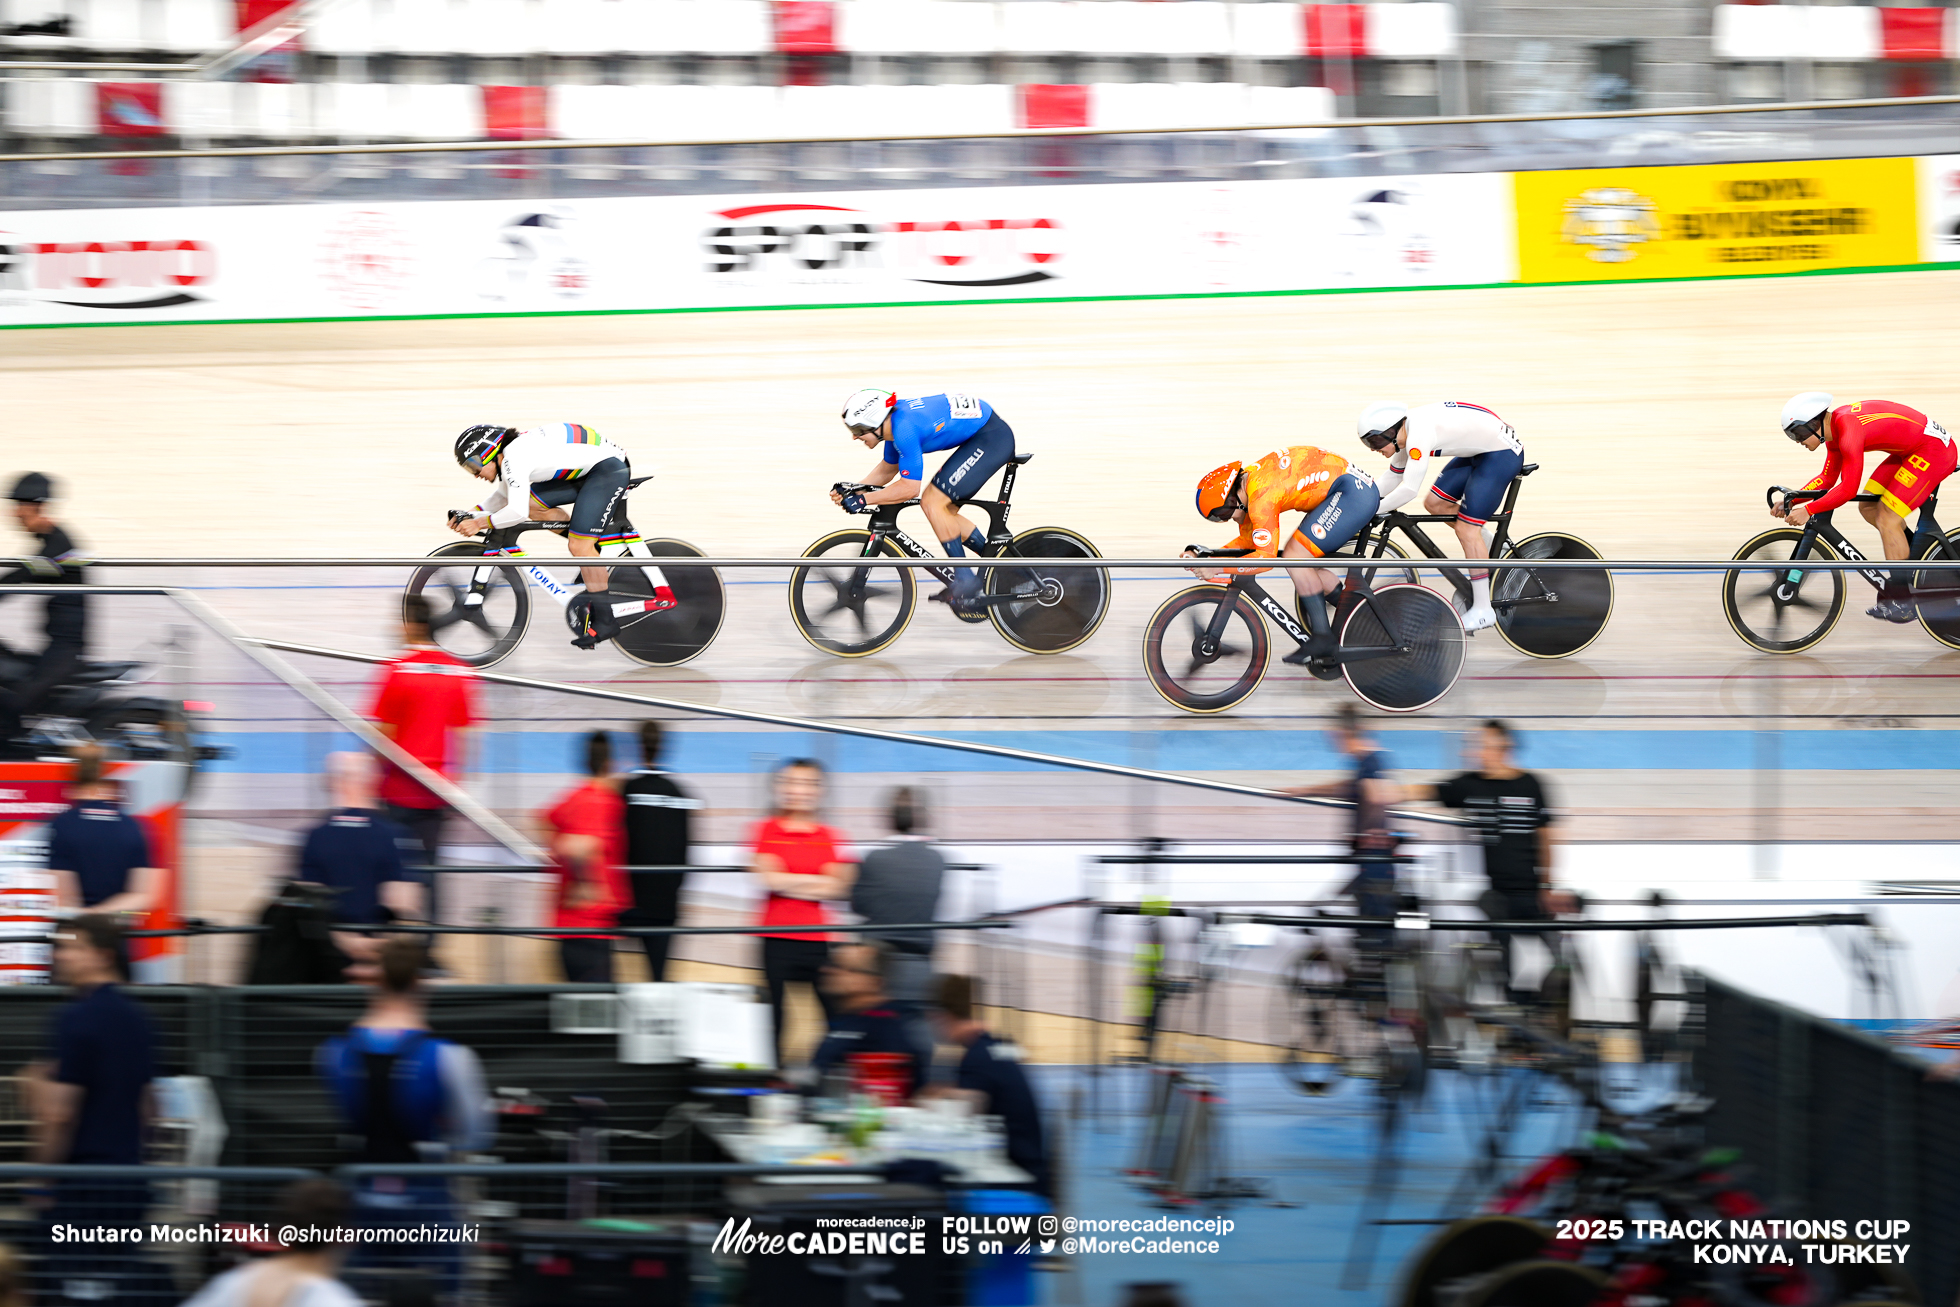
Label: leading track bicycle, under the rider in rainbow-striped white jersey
xmin=406 ymin=476 xmax=727 ymax=666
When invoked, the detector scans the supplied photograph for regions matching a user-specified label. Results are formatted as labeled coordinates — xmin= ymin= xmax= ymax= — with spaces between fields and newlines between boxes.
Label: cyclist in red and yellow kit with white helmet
xmin=1770 ymin=390 xmax=1956 ymax=621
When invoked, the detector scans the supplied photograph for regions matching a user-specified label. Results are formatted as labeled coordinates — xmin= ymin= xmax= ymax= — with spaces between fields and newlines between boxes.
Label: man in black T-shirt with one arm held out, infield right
xmin=1407 ymin=719 xmax=1574 ymax=987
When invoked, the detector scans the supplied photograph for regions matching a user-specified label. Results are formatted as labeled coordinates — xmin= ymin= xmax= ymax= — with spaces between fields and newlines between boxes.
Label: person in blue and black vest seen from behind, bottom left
xmin=313 ymin=939 xmax=492 ymax=1301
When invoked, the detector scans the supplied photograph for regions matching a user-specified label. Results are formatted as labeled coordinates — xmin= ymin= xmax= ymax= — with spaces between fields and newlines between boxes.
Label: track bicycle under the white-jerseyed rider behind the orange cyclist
xmin=1331 ymin=462 xmax=1613 ymax=658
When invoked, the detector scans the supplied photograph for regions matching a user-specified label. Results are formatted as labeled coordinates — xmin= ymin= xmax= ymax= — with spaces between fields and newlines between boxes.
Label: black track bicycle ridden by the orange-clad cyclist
xmin=1143 ymin=545 xmax=1464 ymax=713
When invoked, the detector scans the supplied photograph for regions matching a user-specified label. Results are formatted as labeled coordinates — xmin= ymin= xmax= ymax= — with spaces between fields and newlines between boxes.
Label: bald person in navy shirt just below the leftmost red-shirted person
xmin=296 ymin=752 xmax=421 ymax=962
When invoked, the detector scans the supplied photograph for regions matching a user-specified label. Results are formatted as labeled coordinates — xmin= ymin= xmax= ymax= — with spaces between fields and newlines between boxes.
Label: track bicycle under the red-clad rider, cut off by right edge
xmin=1721 ymin=486 xmax=1960 ymax=653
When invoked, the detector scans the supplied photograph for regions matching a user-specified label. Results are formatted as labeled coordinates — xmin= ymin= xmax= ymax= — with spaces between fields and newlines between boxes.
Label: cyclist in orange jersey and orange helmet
xmin=1184 ymin=445 xmax=1382 ymax=666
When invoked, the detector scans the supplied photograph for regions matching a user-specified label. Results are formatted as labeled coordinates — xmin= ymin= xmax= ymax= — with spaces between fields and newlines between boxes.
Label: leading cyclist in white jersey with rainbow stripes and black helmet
xmin=449 ymin=421 xmax=676 ymax=649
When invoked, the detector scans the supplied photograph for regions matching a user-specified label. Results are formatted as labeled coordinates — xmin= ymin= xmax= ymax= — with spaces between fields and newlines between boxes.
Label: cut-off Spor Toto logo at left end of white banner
xmin=0 ymin=233 xmax=218 ymax=310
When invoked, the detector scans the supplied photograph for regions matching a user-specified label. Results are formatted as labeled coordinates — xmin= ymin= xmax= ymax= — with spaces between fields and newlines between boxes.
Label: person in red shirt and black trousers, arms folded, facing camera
xmin=749 ymin=758 xmax=857 ymax=1066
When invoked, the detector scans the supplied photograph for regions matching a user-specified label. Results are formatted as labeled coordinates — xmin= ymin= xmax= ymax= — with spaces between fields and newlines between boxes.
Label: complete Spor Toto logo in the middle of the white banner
xmin=702 ymin=204 xmax=1062 ymax=286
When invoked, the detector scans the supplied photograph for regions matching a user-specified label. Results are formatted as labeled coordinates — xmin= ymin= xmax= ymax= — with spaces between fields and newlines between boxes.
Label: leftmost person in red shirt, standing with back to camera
xmin=368 ymin=594 xmax=476 ymax=877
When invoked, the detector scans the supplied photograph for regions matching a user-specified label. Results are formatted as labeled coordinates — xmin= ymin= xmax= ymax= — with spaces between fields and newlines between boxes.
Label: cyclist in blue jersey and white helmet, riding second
xmin=831 ymin=390 xmax=1015 ymax=611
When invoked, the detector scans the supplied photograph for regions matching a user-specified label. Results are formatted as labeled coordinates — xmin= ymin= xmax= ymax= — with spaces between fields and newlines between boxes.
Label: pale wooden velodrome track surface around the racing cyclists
xmin=0 ymin=272 xmax=1960 ymax=839
